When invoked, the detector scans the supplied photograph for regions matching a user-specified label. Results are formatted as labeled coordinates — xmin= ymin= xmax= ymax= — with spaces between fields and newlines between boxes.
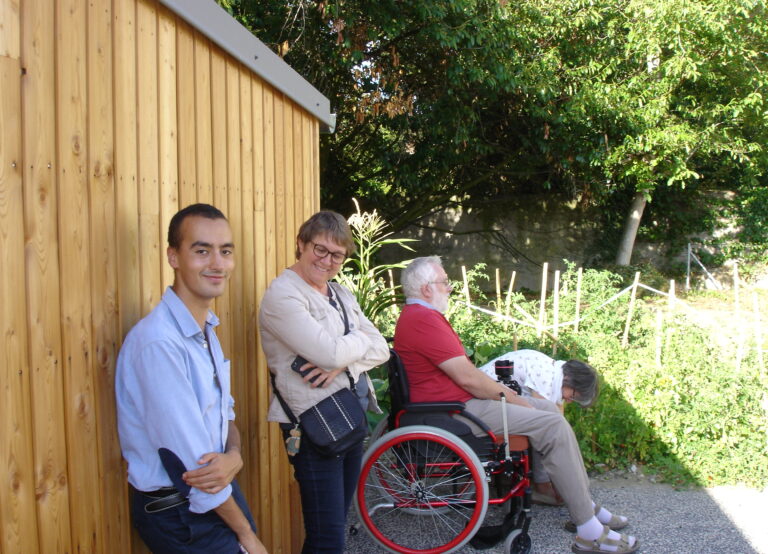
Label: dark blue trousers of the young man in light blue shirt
xmin=131 ymin=481 xmax=256 ymax=554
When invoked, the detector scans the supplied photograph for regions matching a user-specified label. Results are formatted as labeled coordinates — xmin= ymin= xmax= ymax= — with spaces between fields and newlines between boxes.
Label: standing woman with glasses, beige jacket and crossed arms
xmin=259 ymin=211 xmax=389 ymax=553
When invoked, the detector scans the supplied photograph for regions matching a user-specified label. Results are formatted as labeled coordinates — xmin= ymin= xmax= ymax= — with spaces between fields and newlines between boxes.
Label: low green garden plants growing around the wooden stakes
xmin=450 ymin=264 xmax=768 ymax=487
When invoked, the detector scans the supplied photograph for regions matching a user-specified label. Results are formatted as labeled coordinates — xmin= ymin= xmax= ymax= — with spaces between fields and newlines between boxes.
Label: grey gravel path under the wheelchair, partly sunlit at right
xmin=346 ymin=473 xmax=768 ymax=554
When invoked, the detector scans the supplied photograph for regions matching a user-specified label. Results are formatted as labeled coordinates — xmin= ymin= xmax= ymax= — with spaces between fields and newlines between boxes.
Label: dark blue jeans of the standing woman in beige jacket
xmin=283 ymin=425 xmax=363 ymax=554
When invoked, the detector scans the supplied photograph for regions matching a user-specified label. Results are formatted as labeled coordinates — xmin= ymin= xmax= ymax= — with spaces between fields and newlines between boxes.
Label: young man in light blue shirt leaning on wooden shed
xmin=115 ymin=204 xmax=266 ymax=554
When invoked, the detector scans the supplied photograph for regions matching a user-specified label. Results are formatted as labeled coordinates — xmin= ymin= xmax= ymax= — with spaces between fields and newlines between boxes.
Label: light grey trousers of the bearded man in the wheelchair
xmin=466 ymin=398 xmax=595 ymax=525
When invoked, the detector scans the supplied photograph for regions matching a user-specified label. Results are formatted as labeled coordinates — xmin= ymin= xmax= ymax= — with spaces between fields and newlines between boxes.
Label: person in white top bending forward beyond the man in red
xmin=480 ymin=350 xmax=599 ymax=506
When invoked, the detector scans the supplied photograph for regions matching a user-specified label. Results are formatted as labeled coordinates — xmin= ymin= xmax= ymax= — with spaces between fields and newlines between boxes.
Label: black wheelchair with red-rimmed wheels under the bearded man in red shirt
xmin=355 ymin=349 xmax=531 ymax=554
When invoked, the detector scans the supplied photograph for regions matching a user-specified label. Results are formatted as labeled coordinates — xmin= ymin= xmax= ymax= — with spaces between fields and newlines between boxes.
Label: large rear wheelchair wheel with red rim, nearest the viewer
xmin=355 ymin=425 xmax=488 ymax=553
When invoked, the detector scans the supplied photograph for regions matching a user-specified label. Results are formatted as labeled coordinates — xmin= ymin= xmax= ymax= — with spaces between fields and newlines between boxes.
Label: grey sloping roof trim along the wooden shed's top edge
xmin=159 ymin=0 xmax=336 ymax=133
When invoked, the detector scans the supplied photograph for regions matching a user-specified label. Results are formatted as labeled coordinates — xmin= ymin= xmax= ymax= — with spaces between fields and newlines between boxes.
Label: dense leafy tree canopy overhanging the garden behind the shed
xmin=220 ymin=0 xmax=768 ymax=243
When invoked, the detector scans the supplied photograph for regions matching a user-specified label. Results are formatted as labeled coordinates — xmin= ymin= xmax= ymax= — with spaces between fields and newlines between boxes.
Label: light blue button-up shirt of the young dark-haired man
xmin=115 ymin=287 xmax=235 ymax=513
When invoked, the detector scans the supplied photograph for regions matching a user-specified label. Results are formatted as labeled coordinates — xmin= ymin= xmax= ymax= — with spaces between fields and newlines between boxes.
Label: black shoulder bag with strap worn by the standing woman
xmin=270 ymin=282 xmax=368 ymax=457
